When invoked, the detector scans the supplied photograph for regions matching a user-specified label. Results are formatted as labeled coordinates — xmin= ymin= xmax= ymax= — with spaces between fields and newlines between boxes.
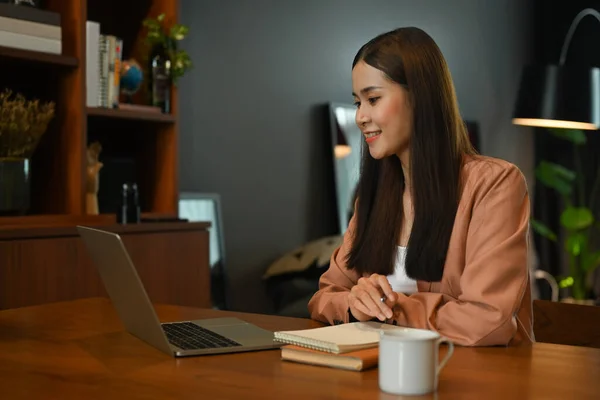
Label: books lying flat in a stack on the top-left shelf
xmin=0 ymin=3 xmax=62 ymax=54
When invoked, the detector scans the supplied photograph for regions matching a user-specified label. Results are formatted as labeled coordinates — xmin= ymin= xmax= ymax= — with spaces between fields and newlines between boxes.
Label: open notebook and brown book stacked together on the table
xmin=275 ymin=322 xmax=386 ymax=371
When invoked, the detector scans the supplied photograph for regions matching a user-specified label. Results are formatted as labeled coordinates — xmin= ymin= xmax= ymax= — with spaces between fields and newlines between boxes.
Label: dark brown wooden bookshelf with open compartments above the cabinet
xmin=0 ymin=0 xmax=179 ymax=225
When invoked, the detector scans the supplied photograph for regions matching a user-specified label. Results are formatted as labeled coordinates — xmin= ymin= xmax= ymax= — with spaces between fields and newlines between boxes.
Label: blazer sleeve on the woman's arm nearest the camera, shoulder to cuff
xmin=394 ymin=166 xmax=530 ymax=346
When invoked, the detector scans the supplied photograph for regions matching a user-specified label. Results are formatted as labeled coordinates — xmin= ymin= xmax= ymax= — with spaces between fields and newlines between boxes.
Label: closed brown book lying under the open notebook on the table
xmin=281 ymin=344 xmax=379 ymax=371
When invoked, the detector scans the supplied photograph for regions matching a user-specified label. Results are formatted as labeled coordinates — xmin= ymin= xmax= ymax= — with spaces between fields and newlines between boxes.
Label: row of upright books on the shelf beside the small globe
xmin=85 ymin=21 xmax=123 ymax=108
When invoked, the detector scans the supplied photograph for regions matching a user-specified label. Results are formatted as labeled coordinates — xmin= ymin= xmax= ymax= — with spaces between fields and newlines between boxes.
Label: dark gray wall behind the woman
xmin=179 ymin=0 xmax=533 ymax=312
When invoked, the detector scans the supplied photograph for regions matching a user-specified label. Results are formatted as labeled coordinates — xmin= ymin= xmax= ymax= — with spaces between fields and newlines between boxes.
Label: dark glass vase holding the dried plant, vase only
xmin=0 ymin=158 xmax=31 ymax=215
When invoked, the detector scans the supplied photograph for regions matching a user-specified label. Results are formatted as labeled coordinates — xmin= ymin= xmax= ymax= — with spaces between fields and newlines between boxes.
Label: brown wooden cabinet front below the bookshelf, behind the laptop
xmin=0 ymin=223 xmax=211 ymax=309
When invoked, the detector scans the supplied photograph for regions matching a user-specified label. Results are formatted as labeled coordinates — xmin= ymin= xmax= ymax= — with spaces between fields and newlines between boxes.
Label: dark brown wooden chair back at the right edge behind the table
xmin=533 ymin=300 xmax=600 ymax=348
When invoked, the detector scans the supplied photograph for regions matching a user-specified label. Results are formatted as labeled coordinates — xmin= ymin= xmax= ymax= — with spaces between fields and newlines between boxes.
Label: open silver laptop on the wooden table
xmin=77 ymin=226 xmax=282 ymax=357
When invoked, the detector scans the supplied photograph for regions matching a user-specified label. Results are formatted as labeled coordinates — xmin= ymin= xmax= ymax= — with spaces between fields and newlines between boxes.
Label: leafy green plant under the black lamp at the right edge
xmin=531 ymin=129 xmax=600 ymax=304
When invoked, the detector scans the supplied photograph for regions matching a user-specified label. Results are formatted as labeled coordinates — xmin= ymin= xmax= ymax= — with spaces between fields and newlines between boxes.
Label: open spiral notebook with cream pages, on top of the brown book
xmin=274 ymin=321 xmax=396 ymax=354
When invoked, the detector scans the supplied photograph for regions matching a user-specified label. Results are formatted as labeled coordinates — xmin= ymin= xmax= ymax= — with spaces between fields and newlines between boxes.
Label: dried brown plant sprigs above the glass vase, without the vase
xmin=0 ymin=89 xmax=54 ymax=159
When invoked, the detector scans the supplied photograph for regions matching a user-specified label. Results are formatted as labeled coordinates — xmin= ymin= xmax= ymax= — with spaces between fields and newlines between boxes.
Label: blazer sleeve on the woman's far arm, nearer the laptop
xmin=308 ymin=211 xmax=359 ymax=325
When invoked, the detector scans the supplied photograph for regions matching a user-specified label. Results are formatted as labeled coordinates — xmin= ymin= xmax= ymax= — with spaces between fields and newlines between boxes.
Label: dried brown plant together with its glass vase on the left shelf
xmin=0 ymin=89 xmax=54 ymax=215
